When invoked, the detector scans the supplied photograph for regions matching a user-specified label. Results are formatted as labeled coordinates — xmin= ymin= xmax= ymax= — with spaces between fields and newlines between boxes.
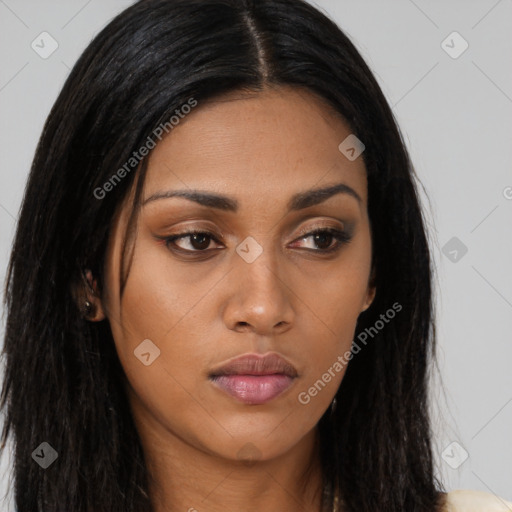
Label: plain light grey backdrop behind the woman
xmin=0 ymin=0 xmax=512 ymax=510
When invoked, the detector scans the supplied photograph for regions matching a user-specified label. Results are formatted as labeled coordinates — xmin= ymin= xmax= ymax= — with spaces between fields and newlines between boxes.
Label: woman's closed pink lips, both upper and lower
xmin=209 ymin=354 xmax=298 ymax=405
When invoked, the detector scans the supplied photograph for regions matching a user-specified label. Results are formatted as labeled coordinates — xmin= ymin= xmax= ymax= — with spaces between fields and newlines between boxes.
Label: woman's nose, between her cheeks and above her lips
xmin=223 ymin=251 xmax=295 ymax=336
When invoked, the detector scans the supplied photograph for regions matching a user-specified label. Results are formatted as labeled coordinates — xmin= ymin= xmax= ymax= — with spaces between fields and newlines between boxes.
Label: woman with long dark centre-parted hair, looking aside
xmin=1 ymin=0 xmax=507 ymax=512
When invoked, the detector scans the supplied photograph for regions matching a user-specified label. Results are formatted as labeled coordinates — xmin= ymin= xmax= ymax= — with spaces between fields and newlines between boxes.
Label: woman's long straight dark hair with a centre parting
xmin=0 ymin=0 xmax=443 ymax=512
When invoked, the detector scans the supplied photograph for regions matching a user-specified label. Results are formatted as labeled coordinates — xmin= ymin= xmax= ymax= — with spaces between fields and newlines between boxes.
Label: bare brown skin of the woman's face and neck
xmin=89 ymin=88 xmax=375 ymax=512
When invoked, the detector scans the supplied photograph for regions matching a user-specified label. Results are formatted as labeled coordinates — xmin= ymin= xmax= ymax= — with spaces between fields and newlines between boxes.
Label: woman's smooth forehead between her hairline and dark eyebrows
xmin=144 ymin=87 xmax=367 ymax=207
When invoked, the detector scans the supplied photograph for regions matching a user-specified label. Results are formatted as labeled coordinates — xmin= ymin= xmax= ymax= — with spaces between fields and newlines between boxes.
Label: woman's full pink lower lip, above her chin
xmin=211 ymin=374 xmax=293 ymax=404
